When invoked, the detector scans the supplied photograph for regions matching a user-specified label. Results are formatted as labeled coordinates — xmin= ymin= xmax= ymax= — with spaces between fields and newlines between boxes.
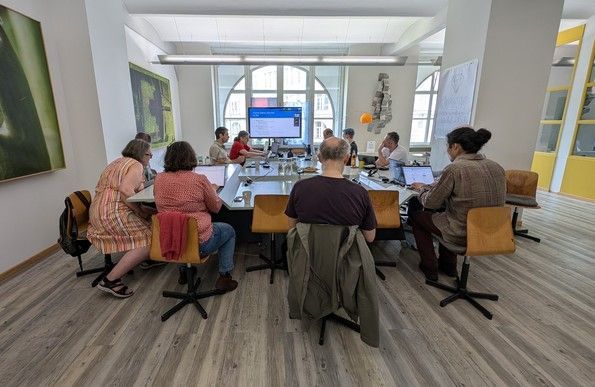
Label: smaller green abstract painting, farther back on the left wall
xmin=130 ymin=63 xmax=175 ymax=148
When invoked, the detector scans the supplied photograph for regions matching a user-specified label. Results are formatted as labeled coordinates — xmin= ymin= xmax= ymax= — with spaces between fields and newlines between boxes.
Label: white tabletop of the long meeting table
xmin=128 ymin=159 xmax=417 ymax=210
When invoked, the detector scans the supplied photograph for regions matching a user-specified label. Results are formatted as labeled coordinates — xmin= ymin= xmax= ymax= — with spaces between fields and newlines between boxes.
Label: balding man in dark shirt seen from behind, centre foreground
xmin=285 ymin=137 xmax=376 ymax=242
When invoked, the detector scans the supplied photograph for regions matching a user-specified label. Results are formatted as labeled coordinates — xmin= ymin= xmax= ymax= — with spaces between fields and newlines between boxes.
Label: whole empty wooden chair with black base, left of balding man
xmin=246 ymin=195 xmax=289 ymax=284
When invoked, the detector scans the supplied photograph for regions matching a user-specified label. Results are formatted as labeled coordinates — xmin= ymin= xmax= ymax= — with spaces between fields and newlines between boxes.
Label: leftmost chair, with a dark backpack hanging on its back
xmin=58 ymin=190 xmax=113 ymax=287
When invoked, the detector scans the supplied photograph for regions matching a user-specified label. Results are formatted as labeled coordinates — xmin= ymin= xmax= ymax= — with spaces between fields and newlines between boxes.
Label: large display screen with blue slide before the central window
xmin=248 ymin=107 xmax=302 ymax=138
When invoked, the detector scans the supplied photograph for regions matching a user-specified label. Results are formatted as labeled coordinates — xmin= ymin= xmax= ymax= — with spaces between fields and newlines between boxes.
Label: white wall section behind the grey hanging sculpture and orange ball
xmin=342 ymin=47 xmax=417 ymax=152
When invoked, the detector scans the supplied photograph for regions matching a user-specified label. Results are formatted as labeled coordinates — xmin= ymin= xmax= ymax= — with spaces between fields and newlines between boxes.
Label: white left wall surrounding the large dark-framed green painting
xmin=0 ymin=0 xmax=106 ymax=272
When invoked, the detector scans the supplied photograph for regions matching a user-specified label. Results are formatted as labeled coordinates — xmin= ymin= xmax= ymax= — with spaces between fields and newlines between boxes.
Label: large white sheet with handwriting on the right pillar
xmin=434 ymin=59 xmax=478 ymax=138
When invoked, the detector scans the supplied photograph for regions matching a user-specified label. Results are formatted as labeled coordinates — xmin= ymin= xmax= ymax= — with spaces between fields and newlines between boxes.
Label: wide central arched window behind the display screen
xmin=216 ymin=65 xmax=343 ymax=145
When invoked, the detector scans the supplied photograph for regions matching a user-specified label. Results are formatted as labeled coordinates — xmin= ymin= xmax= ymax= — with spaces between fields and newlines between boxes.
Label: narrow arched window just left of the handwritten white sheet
xmin=411 ymin=71 xmax=440 ymax=145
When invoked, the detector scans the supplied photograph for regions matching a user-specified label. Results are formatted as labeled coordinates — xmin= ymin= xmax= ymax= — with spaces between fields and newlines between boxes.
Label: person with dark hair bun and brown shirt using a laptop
xmin=410 ymin=127 xmax=506 ymax=280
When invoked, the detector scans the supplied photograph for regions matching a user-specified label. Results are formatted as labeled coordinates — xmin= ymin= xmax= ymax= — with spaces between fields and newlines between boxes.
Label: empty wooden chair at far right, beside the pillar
xmin=506 ymin=169 xmax=541 ymax=243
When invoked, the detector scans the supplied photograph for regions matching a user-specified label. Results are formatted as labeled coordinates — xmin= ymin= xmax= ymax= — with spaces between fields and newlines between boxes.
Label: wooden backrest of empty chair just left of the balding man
xmin=252 ymin=195 xmax=289 ymax=234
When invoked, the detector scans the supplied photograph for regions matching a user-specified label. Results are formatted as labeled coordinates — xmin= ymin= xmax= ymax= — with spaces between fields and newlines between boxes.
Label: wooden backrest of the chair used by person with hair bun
xmin=466 ymin=207 xmax=516 ymax=257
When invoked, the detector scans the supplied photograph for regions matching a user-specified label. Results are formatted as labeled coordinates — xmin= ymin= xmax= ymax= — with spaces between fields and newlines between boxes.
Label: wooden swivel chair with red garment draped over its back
xmin=149 ymin=215 xmax=224 ymax=321
